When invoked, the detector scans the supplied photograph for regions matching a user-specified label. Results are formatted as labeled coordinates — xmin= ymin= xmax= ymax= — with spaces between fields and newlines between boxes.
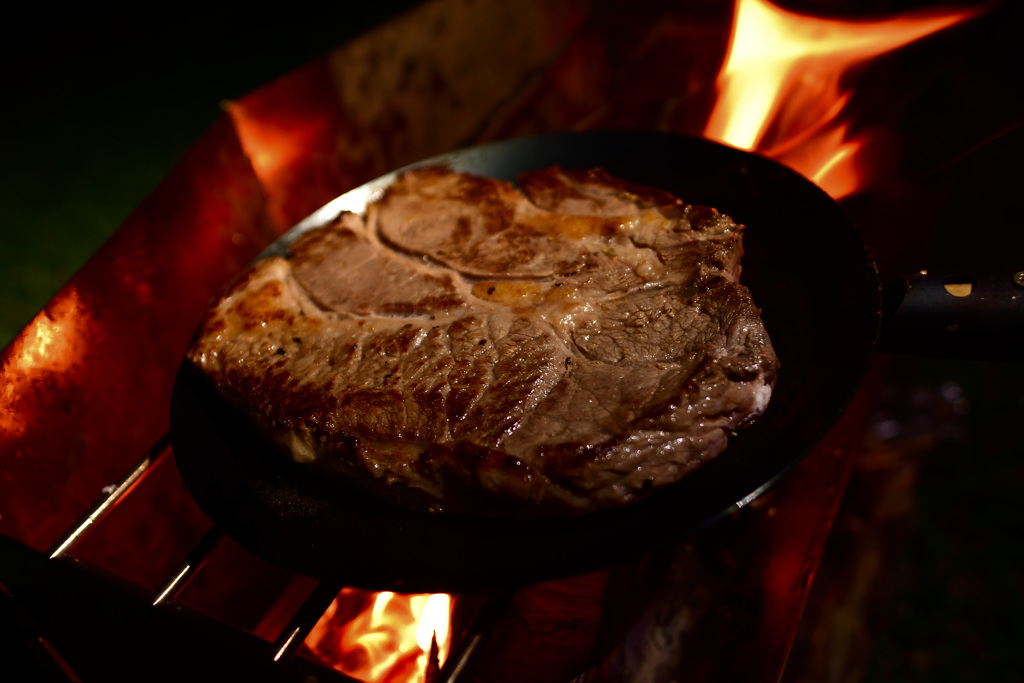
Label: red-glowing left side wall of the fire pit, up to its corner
xmin=0 ymin=113 xmax=273 ymax=561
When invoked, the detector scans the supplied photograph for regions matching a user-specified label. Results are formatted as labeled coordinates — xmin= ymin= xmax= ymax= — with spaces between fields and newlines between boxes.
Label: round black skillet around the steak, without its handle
xmin=171 ymin=132 xmax=881 ymax=592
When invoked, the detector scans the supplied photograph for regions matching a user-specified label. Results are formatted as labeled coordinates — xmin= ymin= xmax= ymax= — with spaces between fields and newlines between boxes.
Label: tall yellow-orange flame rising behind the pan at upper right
xmin=705 ymin=0 xmax=981 ymax=199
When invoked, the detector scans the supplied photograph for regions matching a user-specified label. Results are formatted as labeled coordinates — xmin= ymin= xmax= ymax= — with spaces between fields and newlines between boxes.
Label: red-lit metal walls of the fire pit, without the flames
xmin=0 ymin=0 xmax=974 ymax=681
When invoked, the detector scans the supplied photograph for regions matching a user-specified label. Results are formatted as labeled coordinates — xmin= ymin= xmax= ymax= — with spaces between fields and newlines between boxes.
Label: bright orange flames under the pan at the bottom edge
xmin=305 ymin=588 xmax=452 ymax=683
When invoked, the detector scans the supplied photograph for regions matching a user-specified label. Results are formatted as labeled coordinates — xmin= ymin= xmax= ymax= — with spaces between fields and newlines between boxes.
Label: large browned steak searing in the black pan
xmin=188 ymin=167 xmax=778 ymax=515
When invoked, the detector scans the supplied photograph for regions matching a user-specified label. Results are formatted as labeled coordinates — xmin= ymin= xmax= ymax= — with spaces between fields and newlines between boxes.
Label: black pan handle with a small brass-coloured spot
xmin=878 ymin=270 xmax=1024 ymax=360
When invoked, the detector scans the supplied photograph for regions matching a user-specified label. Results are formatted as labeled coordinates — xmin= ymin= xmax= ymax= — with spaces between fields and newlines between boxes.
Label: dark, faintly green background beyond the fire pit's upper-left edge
xmin=0 ymin=0 xmax=417 ymax=347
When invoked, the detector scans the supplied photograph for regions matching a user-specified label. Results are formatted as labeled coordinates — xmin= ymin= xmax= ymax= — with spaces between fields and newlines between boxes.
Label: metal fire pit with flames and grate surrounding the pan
xmin=0 ymin=0 xmax=1024 ymax=681
